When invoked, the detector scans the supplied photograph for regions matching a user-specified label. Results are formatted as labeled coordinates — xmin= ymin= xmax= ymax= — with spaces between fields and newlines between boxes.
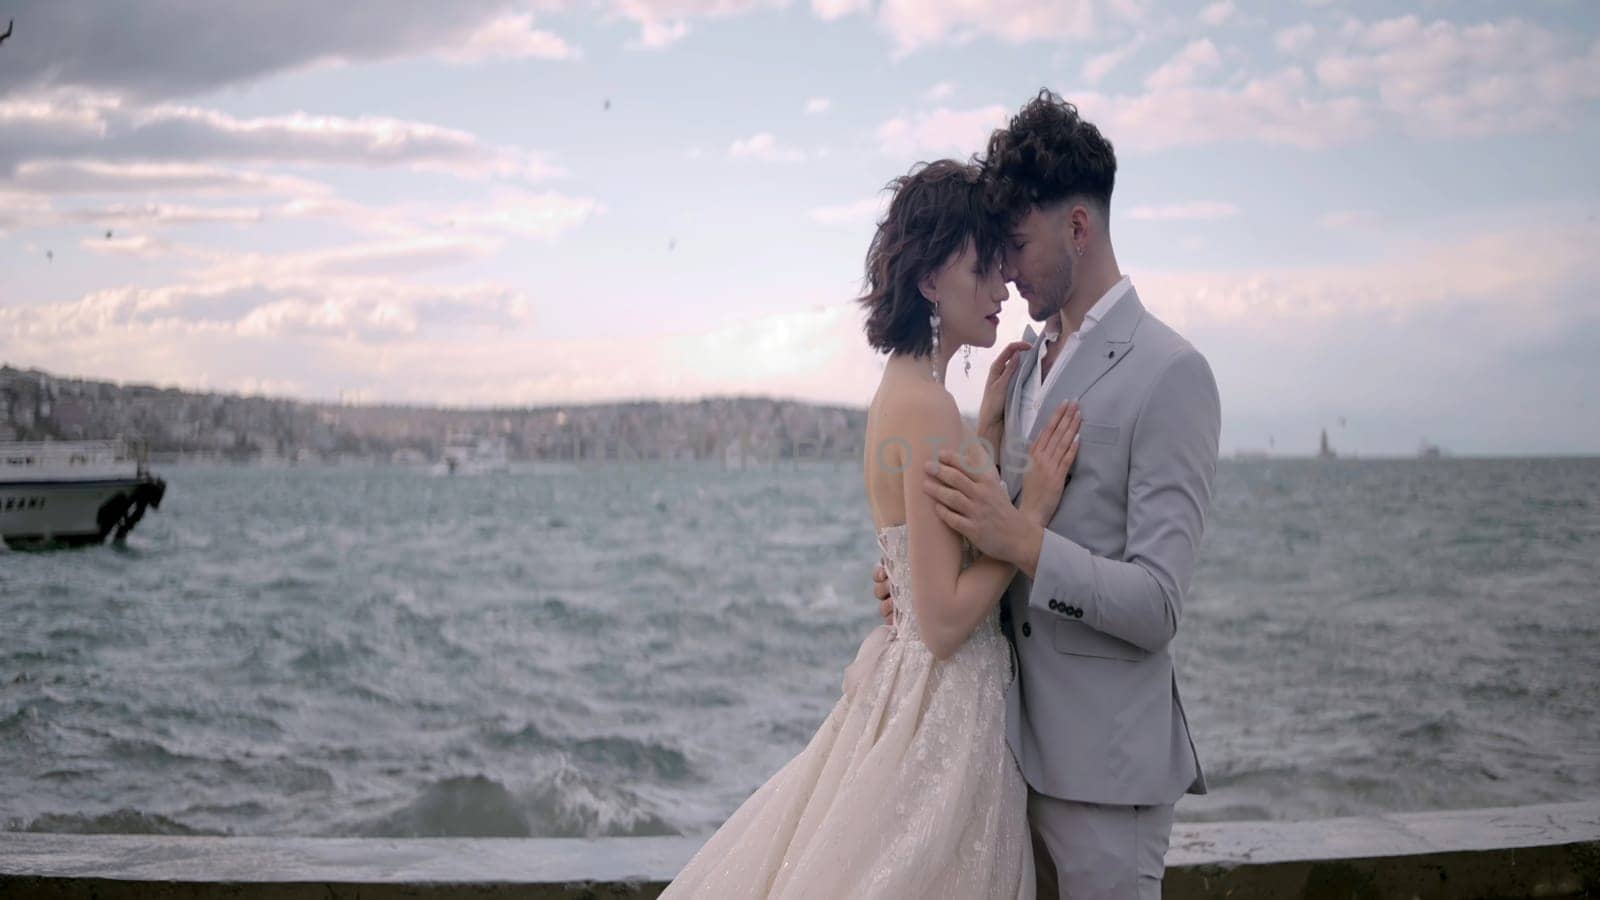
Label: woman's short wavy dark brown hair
xmin=856 ymin=160 xmax=1003 ymax=356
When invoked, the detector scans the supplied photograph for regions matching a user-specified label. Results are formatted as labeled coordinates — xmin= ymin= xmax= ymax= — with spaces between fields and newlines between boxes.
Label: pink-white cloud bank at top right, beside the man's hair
xmin=1072 ymin=16 xmax=1600 ymax=152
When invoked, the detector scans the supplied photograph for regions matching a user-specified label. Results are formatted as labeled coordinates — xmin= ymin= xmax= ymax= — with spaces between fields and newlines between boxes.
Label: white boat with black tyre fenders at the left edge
xmin=0 ymin=440 xmax=166 ymax=548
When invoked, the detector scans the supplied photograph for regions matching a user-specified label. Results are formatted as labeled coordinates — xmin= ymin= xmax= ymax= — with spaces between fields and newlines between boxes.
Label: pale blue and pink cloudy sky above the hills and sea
xmin=0 ymin=0 xmax=1600 ymax=455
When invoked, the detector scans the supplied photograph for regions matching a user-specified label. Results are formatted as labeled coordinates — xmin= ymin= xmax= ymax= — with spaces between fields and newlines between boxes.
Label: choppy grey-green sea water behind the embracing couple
xmin=0 ymin=460 xmax=1600 ymax=836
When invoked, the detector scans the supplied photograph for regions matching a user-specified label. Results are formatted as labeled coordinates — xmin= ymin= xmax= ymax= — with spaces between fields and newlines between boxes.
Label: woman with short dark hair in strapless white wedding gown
xmin=661 ymin=160 xmax=1078 ymax=900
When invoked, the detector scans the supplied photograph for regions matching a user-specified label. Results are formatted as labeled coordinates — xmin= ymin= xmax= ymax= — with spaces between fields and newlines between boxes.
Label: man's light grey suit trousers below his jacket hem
xmin=1027 ymin=790 xmax=1173 ymax=900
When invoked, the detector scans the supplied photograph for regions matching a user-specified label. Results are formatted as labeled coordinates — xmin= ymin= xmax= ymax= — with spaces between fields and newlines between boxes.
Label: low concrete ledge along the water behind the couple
xmin=0 ymin=801 xmax=1600 ymax=900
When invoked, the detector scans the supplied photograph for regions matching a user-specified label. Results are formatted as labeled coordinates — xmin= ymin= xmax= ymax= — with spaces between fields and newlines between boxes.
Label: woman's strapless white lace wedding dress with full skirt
xmin=661 ymin=525 xmax=1034 ymax=900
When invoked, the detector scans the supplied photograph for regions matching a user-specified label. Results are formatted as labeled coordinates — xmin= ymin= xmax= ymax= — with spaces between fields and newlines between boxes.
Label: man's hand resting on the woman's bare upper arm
xmin=922 ymin=450 xmax=1043 ymax=573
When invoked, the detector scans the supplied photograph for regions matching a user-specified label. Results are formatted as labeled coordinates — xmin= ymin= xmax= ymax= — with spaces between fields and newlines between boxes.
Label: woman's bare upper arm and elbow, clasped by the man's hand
xmin=901 ymin=391 xmax=1016 ymax=660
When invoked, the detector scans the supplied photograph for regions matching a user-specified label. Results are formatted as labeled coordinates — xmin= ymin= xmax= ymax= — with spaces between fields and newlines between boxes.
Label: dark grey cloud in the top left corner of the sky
xmin=0 ymin=0 xmax=576 ymax=99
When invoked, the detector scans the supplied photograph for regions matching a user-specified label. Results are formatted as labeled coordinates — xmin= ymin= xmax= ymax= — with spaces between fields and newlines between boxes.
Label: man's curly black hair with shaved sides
xmin=981 ymin=88 xmax=1117 ymax=224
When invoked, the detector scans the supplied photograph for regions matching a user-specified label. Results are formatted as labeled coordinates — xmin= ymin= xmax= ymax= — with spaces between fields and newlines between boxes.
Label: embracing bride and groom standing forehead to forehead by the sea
xmin=662 ymin=91 xmax=1219 ymax=900
